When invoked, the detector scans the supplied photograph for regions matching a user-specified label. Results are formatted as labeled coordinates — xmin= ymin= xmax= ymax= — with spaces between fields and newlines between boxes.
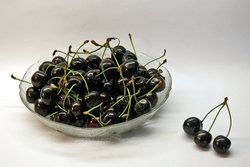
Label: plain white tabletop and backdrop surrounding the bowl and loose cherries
xmin=0 ymin=0 xmax=250 ymax=167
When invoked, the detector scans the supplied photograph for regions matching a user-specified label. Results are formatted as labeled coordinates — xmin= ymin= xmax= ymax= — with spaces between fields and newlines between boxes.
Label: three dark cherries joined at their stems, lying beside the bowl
xmin=183 ymin=97 xmax=232 ymax=154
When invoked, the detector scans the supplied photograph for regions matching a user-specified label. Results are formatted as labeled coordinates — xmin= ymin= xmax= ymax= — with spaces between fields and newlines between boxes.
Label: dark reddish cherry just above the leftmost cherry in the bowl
xmin=31 ymin=71 xmax=48 ymax=88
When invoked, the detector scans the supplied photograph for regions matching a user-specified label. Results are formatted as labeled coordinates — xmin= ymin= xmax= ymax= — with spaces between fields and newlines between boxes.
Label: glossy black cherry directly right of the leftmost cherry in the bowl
xmin=40 ymin=85 xmax=57 ymax=105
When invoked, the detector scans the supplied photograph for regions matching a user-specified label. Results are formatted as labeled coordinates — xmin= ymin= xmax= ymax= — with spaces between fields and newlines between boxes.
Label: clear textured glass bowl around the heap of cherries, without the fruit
xmin=19 ymin=52 xmax=172 ymax=137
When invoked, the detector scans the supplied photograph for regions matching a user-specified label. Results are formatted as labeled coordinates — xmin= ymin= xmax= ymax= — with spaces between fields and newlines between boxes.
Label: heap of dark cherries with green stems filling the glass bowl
xmin=12 ymin=34 xmax=166 ymax=128
